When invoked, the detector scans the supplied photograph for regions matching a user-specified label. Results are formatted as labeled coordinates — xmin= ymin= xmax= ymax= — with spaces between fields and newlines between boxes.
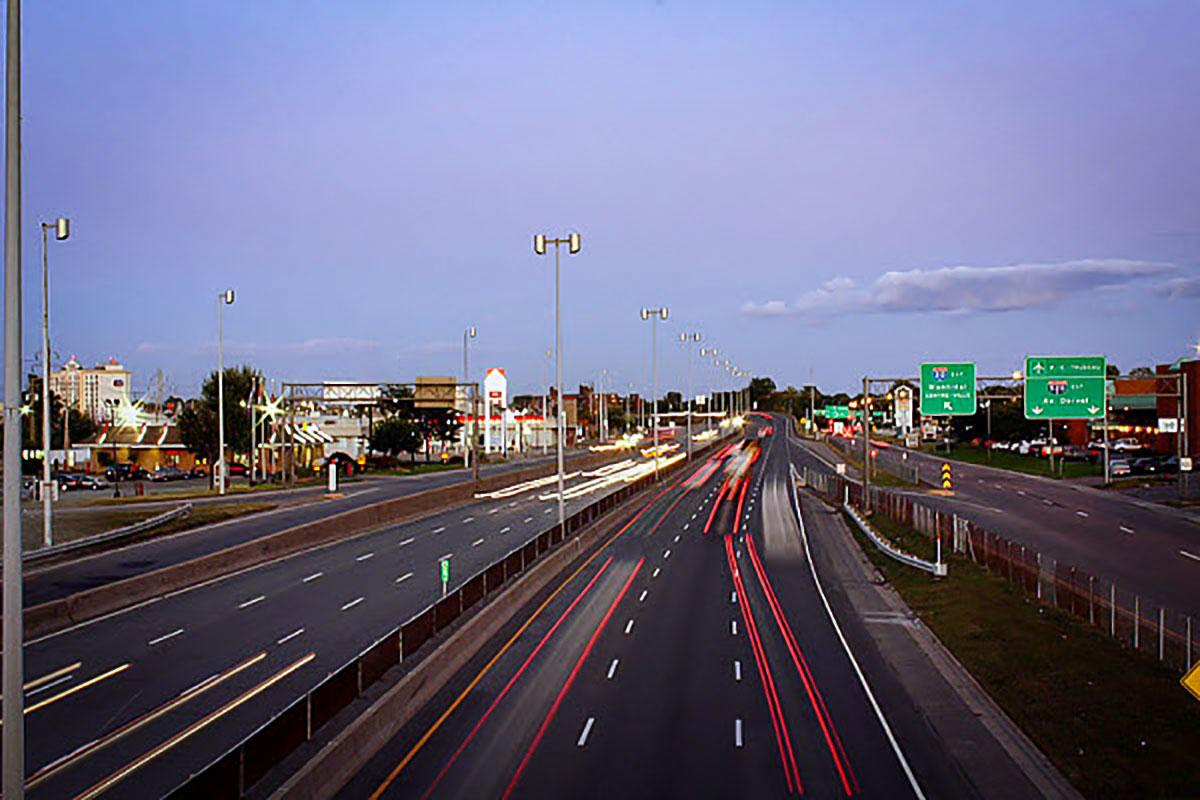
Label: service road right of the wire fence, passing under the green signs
xmin=796 ymin=440 xmax=1200 ymax=615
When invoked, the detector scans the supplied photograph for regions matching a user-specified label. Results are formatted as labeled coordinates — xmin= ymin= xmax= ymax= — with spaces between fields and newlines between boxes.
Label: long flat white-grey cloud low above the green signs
xmin=742 ymin=259 xmax=1176 ymax=317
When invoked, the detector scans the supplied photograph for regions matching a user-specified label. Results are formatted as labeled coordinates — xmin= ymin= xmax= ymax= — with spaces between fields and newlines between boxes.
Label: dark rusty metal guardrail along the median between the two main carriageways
xmin=167 ymin=439 xmax=721 ymax=800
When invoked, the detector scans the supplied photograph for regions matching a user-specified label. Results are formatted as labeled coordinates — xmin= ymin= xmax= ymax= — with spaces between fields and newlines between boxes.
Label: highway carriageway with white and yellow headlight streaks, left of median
xmin=11 ymin=453 xmax=667 ymax=798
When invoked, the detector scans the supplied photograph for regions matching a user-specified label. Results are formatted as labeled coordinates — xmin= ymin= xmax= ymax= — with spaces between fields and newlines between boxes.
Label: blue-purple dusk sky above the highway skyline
xmin=11 ymin=0 xmax=1200 ymax=395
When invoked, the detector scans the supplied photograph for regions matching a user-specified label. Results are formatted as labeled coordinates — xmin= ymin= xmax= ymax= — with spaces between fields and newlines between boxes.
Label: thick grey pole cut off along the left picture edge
xmin=0 ymin=0 xmax=25 ymax=786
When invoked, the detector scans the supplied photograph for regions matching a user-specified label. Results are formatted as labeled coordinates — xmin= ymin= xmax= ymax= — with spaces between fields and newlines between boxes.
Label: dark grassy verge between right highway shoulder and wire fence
xmin=847 ymin=506 xmax=1200 ymax=798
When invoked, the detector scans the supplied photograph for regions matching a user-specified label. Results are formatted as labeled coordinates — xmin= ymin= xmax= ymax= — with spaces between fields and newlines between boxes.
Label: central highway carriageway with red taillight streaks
xmin=342 ymin=423 xmax=984 ymax=799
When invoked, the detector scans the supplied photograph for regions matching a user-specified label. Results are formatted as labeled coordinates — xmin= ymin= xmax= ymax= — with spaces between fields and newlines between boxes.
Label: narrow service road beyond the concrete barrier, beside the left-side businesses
xmin=25 ymin=451 xmax=609 ymax=606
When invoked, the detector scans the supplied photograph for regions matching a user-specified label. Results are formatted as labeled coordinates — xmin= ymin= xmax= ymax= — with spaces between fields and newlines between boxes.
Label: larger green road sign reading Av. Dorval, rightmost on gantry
xmin=1025 ymin=355 xmax=1108 ymax=420
